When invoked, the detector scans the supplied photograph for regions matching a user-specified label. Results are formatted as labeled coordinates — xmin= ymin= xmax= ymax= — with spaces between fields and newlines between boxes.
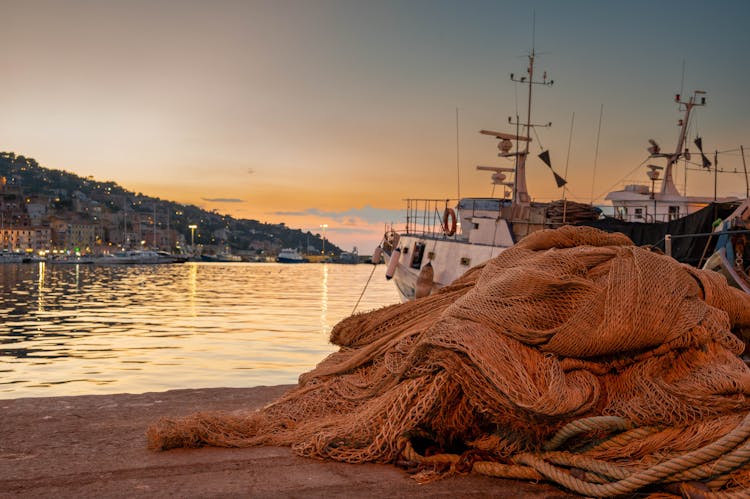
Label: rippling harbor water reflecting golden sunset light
xmin=0 ymin=263 xmax=398 ymax=399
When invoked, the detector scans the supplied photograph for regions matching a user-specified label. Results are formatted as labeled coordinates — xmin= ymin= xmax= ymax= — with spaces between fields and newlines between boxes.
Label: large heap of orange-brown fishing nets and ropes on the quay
xmin=148 ymin=226 xmax=750 ymax=496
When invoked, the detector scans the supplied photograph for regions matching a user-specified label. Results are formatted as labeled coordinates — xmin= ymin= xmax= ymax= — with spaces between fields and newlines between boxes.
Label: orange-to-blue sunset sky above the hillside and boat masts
xmin=0 ymin=0 xmax=750 ymax=250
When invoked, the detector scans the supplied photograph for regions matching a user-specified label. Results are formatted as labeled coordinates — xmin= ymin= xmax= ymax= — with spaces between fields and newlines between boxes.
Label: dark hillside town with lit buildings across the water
xmin=0 ymin=152 xmax=341 ymax=261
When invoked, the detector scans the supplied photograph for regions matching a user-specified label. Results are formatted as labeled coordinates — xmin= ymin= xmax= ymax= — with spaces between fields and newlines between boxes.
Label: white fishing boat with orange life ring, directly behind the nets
xmin=382 ymin=50 xmax=599 ymax=301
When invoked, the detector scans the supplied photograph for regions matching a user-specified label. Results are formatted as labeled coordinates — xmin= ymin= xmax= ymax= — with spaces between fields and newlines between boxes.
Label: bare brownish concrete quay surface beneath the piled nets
xmin=0 ymin=385 xmax=574 ymax=498
